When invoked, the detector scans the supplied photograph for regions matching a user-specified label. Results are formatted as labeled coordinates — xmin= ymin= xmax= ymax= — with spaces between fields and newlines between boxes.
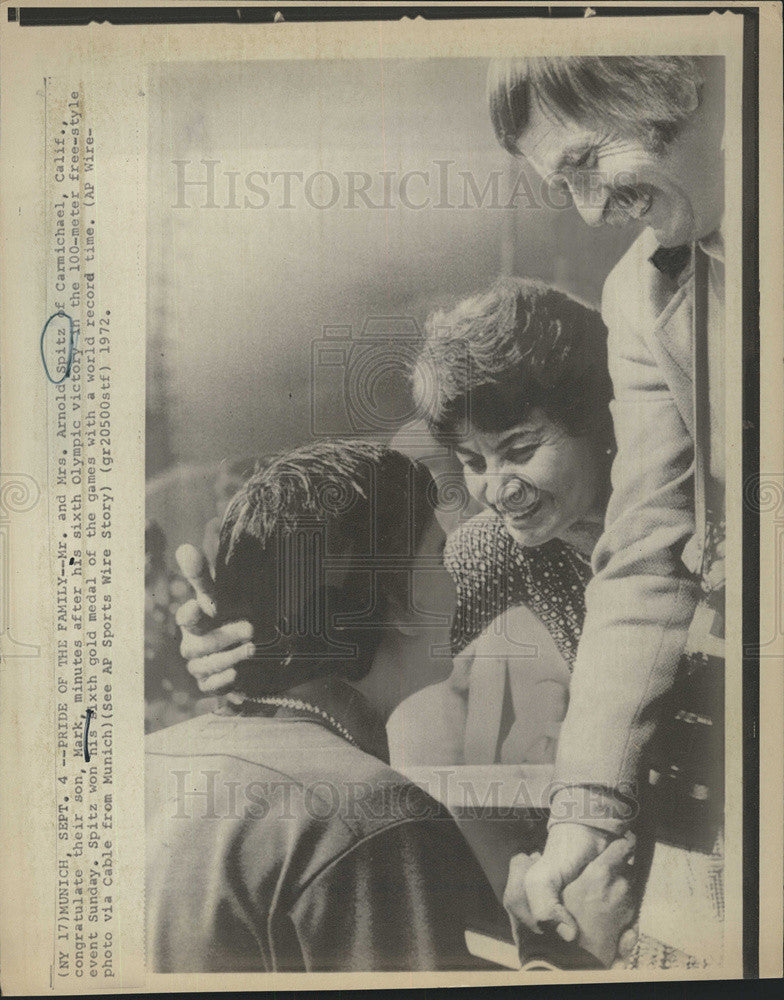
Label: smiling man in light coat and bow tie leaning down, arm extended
xmin=489 ymin=57 xmax=725 ymax=952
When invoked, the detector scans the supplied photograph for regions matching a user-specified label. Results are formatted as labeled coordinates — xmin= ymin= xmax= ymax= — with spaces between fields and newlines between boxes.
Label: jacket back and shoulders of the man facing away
xmin=146 ymin=717 xmax=495 ymax=971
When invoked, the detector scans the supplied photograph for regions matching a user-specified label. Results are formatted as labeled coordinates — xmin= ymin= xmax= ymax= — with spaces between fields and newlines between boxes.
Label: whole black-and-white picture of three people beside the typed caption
xmin=145 ymin=48 xmax=725 ymax=973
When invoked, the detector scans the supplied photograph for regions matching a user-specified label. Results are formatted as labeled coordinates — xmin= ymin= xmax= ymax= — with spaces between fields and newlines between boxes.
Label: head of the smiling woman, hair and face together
xmin=413 ymin=278 xmax=613 ymax=552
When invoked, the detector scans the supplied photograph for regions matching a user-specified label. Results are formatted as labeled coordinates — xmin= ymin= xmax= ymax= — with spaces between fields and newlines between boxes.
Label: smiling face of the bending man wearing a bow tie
xmin=517 ymin=96 xmax=724 ymax=247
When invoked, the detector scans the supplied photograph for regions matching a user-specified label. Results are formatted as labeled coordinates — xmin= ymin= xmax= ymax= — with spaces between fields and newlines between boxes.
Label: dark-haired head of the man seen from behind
xmin=216 ymin=440 xmax=437 ymax=695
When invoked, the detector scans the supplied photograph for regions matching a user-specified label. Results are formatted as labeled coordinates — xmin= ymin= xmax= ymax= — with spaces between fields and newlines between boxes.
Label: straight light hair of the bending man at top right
xmin=487 ymin=56 xmax=702 ymax=156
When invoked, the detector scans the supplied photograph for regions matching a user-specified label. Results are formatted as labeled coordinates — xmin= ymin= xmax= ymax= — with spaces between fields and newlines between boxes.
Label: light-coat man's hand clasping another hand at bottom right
xmin=504 ymin=823 xmax=610 ymax=941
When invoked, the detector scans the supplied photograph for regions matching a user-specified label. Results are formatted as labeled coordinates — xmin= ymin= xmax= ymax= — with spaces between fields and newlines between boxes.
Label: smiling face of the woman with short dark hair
xmin=455 ymin=410 xmax=602 ymax=546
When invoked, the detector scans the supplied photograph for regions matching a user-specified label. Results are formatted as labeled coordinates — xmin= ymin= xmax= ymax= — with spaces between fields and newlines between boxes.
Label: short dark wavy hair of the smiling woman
xmin=412 ymin=278 xmax=613 ymax=450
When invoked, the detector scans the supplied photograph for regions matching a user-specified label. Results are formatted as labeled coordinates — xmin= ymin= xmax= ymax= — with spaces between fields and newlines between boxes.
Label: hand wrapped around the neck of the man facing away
xmin=176 ymin=545 xmax=254 ymax=694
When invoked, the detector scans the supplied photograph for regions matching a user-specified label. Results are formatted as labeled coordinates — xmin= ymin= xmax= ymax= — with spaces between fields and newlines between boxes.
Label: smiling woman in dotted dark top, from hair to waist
xmin=396 ymin=278 xmax=614 ymax=764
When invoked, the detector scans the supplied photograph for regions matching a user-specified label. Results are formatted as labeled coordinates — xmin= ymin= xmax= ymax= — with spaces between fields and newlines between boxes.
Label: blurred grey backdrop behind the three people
xmin=147 ymin=59 xmax=635 ymax=728
